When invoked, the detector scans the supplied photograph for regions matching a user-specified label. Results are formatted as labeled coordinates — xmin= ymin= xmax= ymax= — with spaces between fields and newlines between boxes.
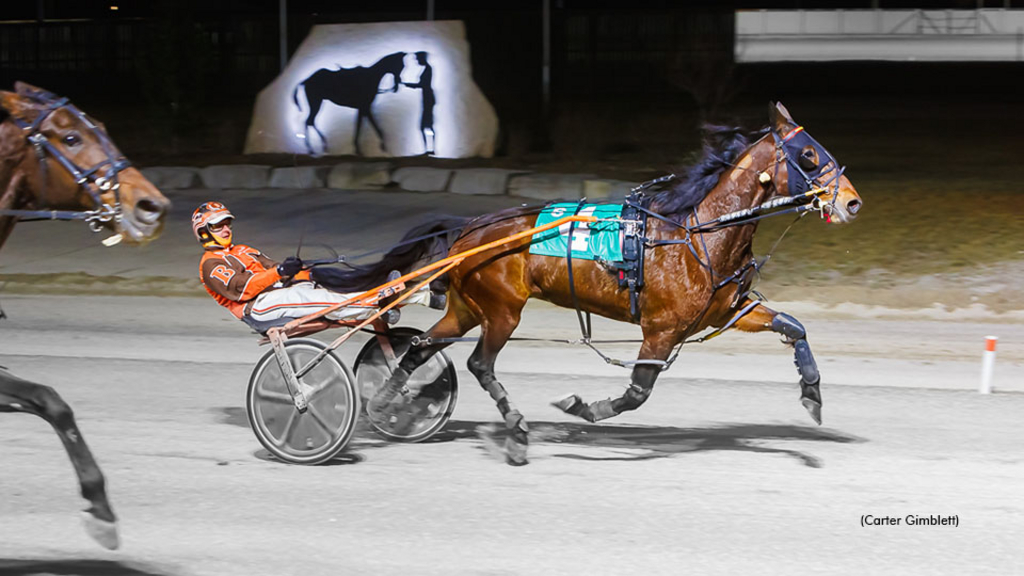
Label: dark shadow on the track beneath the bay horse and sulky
xmin=220 ymin=408 xmax=867 ymax=468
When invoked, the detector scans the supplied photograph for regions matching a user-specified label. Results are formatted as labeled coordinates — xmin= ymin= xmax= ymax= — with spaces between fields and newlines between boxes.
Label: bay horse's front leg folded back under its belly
xmin=552 ymin=333 xmax=679 ymax=422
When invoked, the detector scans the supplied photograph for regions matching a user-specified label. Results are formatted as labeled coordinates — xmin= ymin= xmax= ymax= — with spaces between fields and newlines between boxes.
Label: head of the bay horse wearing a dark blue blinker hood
xmin=763 ymin=102 xmax=863 ymax=223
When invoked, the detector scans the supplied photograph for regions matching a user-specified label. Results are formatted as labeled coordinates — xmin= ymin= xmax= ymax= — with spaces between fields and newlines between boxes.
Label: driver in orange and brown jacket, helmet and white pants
xmin=193 ymin=202 xmax=443 ymax=333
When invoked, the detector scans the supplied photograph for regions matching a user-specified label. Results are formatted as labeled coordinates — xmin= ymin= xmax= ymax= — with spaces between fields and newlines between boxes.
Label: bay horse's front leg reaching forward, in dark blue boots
xmin=735 ymin=300 xmax=821 ymax=424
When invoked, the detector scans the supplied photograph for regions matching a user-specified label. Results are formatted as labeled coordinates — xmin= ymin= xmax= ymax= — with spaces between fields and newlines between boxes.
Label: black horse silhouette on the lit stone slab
xmin=292 ymin=52 xmax=406 ymax=156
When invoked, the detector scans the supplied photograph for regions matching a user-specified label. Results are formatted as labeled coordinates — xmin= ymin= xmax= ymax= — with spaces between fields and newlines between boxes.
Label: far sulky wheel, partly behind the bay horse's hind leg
xmin=355 ymin=327 xmax=459 ymax=442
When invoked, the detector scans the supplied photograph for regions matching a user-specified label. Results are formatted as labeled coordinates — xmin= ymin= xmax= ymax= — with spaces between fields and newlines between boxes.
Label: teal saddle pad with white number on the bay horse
xmin=529 ymin=202 xmax=623 ymax=262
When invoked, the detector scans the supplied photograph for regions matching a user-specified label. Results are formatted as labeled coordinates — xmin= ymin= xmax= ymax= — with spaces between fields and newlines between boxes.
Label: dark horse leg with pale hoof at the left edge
xmin=0 ymin=370 xmax=120 ymax=549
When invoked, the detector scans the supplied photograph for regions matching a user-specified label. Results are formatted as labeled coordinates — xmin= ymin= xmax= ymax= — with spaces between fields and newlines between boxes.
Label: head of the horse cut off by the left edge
xmin=0 ymin=82 xmax=171 ymax=244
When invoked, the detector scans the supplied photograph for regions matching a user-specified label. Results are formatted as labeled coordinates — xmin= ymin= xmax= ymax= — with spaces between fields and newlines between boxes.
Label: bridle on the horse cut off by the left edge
xmin=0 ymin=94 xmax=131 ymax=232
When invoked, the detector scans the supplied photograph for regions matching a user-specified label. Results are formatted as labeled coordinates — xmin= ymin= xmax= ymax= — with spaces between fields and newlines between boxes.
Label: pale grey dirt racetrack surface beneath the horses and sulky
xmin=0 ymin=192 xmax=1024 ymax=576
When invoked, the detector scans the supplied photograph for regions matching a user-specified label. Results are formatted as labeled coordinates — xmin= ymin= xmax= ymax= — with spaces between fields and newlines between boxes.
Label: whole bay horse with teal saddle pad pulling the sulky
xmin=321 ymin=104 xmax=861 ymax=464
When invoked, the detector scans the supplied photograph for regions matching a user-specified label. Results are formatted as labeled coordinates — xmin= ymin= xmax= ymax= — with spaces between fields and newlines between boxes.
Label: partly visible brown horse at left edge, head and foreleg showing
xmin=0 ymin=82 xmax=170 ymax=548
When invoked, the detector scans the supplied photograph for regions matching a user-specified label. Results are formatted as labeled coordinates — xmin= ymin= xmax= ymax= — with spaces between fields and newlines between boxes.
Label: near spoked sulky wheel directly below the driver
xmin=246 ymin=338 xmax=359 ymax=464
